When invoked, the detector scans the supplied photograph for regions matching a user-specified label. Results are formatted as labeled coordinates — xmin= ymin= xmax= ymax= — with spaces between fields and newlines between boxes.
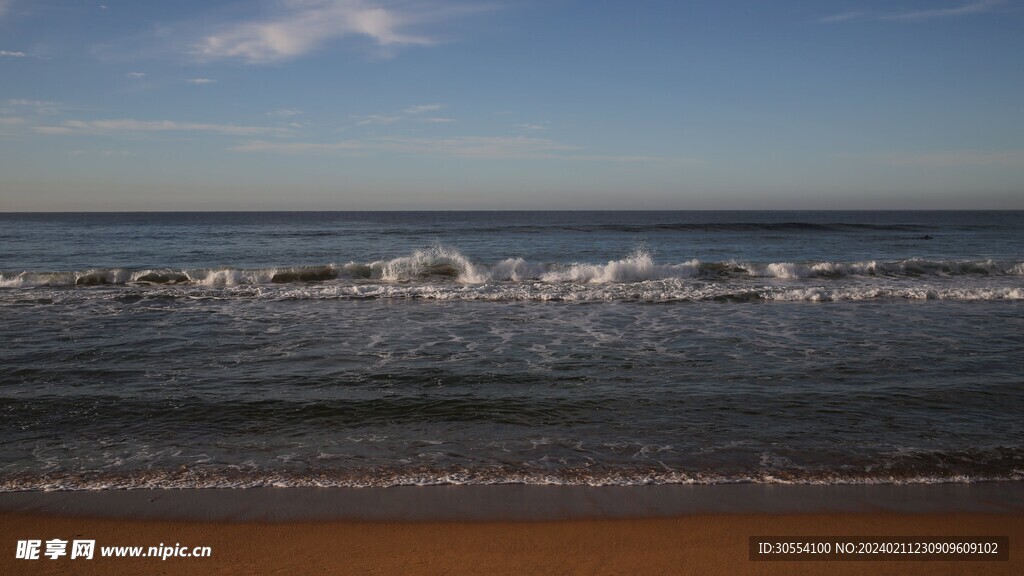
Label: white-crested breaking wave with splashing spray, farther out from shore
xmin=0 ymin=246 xmax=1024 ymax=288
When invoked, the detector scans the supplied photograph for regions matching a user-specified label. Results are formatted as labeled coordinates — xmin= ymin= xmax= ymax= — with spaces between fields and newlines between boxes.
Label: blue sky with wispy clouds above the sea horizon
xmin=0 ymin=0 xmax=1024 ymax=211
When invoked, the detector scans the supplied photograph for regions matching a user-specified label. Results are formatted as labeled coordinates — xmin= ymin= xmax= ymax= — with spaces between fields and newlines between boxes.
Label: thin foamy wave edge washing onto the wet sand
xmin=0 ymin=456 xmax=1024 ymax=492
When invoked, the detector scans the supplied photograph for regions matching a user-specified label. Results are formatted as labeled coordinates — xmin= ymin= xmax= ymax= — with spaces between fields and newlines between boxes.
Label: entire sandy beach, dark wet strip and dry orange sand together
xmin=0 ymin=484 xmax=1024 ymax=575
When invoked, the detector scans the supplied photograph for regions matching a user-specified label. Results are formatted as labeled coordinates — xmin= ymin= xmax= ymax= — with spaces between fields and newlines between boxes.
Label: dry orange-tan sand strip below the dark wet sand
xmin=0 ymin=512 xmax=1024 ymax=576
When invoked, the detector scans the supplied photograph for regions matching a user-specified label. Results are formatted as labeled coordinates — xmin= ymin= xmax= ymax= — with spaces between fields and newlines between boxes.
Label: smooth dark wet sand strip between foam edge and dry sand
xmin=0 ymin=481 xmax=1024 ymax=523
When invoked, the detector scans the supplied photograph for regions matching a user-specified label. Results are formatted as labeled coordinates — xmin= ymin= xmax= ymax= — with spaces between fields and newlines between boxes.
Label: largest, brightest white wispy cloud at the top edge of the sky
xmin=193 ymin=0 xmax=483 ymax=64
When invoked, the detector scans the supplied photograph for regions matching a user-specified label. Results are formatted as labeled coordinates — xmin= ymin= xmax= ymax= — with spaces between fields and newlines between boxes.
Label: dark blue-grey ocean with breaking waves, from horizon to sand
xmin=0 ymin=211 xmax=1024 ymax=491
